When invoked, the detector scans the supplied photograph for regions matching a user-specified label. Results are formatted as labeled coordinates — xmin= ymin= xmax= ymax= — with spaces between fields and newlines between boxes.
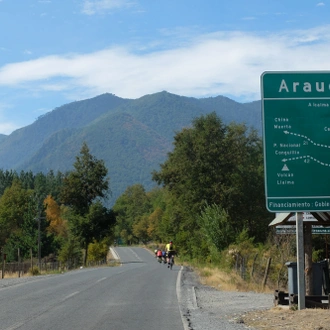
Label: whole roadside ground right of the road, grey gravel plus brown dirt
xmin=179 ymin=267 xmax=330 ymax=330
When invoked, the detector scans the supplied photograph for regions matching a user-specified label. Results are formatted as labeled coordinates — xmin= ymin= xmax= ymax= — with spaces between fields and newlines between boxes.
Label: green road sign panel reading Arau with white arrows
xmin=261 ymin=71 xmax=330 ymax=212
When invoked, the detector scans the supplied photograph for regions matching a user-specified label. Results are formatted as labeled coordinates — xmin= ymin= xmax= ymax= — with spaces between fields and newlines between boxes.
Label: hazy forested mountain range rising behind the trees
xmin=0 ymin=91 xmax=261 ymax=204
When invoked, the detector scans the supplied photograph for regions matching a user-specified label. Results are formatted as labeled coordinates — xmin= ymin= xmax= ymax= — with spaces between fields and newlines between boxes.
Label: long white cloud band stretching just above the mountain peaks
xmin=0 ymin=26 xmax=330 ymax=101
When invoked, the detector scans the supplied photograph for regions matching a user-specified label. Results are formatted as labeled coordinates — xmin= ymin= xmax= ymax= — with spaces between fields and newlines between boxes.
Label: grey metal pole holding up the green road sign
xmin=296 ymin=212 xmax=306 ymax=310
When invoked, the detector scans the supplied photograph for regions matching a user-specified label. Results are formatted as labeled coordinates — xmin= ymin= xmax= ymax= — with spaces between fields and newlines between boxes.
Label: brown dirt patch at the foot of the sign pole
xmin=242 ymin=307 xmax=330 ymax=330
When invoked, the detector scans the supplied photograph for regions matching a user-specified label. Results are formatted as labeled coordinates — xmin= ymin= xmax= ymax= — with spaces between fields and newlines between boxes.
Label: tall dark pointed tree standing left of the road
xmin=61 ymin=142 xmax=114 ymax=264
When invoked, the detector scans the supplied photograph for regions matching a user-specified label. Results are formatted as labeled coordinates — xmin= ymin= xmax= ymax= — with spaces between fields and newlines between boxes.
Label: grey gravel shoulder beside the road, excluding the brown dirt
xmin=179 ymin=267 xmax=273 ymax=330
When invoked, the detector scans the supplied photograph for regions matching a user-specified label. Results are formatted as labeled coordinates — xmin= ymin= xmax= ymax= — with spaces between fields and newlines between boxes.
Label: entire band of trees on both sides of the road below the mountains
xmin=0 ymin=112 xmax=310 ymax=270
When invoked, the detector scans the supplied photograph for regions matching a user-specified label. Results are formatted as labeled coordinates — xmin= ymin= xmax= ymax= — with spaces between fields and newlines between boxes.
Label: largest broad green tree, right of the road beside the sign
xmin=153 ymin=113 xmax=269 ymax=253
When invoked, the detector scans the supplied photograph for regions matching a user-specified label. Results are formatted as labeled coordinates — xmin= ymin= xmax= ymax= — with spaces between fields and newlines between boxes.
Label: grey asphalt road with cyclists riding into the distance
xmin=0 ymin=248 xmax=184 ymax=330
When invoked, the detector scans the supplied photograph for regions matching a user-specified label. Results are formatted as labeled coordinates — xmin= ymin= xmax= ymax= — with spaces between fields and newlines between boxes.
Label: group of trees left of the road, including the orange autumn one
xmin=0 ymin=143 xmax=115 ymax=264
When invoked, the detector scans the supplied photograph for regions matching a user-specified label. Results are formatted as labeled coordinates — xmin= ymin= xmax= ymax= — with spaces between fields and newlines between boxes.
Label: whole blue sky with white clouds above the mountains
xmin=0 ymin=0 xmax=330 ymax=134
